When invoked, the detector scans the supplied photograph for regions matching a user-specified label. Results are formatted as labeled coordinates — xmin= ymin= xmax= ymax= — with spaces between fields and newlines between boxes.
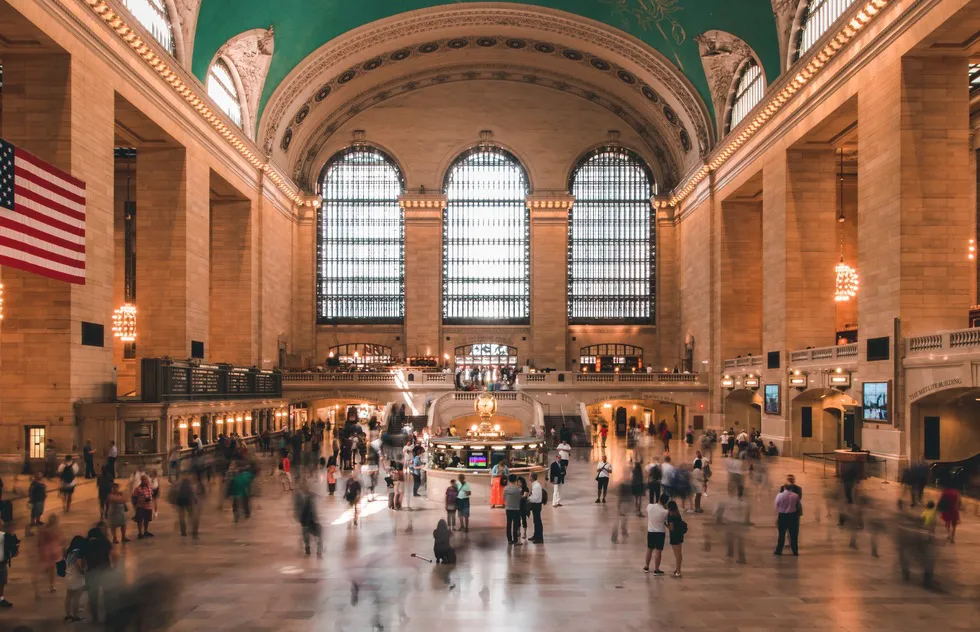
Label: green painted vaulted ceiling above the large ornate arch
xmin=193 ymin=0 xmax=780 ymax=126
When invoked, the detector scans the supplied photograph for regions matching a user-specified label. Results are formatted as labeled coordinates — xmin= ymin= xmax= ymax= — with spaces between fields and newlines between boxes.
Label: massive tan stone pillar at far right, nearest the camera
xmin=852 ymin=57 xmax=976 ymax=477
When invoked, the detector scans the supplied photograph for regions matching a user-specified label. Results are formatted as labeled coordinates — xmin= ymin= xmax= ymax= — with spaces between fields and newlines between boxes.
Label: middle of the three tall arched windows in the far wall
xmin=442 ymin=147 xmax=531 ymax=324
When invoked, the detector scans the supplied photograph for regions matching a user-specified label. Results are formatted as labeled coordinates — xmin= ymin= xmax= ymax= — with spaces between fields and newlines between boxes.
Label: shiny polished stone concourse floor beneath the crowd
xmin=0 ymin=436 xmax=980 ymax=632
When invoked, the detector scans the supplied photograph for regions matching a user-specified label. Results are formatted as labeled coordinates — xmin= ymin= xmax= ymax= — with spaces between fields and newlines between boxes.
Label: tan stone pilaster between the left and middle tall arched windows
xmin=398 ymin=193 xmax=446 ymax=361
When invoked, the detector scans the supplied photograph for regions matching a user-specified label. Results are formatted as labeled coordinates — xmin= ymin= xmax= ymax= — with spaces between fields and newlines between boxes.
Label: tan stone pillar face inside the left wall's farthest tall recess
xmin=207 ymin=200 xmax=258 ymax=366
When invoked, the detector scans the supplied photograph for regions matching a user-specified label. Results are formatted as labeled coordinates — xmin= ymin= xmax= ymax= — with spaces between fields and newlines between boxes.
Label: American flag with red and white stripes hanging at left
xmin=0 ymin=140 xmax=85 ymax=285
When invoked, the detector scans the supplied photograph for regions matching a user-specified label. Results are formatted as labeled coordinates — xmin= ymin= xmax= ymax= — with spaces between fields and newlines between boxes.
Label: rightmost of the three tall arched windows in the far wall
xmin=568 ymin=147 xmax=656 ymax=324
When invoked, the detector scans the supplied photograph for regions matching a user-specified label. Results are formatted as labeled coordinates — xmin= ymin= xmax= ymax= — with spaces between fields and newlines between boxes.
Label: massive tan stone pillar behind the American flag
xmin=0 ymin=51 xmax=114 ymax=456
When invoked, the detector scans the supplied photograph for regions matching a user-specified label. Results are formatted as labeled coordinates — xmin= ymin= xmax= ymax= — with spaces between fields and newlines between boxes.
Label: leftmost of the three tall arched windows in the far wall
xmin=317 ymin=147 xmax=405 ymax=323
